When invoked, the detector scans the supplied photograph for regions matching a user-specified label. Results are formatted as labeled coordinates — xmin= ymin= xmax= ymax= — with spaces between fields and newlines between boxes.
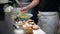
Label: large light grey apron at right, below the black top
xmin=38 ymin=12 xmax=59 ymax=34
